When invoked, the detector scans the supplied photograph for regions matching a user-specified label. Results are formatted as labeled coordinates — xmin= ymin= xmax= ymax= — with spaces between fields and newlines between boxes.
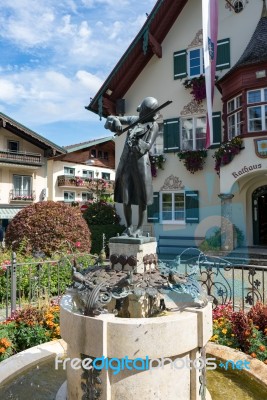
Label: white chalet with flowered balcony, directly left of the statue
xmin=48 ymin=136 xmax=115 ymax=206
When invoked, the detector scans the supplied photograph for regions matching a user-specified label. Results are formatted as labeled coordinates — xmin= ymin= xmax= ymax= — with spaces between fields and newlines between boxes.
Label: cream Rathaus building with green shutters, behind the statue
xmin=88 ymin=0 xmax=267 ymax=251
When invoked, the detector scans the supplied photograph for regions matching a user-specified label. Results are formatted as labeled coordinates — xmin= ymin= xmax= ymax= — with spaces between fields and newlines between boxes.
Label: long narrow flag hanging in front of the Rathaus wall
xmin=202 ymin=0 xmax=218 ymax=148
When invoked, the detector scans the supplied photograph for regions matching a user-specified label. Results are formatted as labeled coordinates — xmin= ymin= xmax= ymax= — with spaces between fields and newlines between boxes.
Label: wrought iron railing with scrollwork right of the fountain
xmin=163 ymin=249 xmax=267 ymax=310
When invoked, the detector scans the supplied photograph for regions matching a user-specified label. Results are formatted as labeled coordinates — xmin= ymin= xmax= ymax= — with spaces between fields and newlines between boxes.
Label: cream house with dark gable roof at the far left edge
xmin=0 ymin=113 xmax=66 ymax=229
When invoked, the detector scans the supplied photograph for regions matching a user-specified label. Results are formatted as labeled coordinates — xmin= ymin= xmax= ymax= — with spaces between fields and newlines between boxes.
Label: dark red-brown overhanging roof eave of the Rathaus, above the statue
xmin=85 ymin=0 xmax=188 ymax=117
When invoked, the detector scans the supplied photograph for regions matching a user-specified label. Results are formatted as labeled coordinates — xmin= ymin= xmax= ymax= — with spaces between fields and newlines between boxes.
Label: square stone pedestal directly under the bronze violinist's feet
xmin=109 ymin=236 xmax=157 ymax=273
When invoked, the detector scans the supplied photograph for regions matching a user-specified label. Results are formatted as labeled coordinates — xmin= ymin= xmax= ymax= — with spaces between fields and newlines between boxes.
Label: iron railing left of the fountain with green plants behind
xmin=0 ymin=253 xmax=98 ymax=320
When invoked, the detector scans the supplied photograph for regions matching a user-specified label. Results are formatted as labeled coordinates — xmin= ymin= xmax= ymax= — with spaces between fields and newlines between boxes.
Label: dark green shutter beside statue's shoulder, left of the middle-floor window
xmin=163 ymin=118 xmax=180 ymax=153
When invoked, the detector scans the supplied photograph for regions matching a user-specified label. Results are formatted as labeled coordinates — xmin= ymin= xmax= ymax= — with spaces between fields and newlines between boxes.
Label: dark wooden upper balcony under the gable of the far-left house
xmin=0 ymin=150 xmax=43 ymax=167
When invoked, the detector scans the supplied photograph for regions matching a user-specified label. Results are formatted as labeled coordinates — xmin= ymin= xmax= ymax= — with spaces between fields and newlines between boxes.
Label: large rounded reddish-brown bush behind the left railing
xmin=5 ymin=201 xmax=91 ymax=256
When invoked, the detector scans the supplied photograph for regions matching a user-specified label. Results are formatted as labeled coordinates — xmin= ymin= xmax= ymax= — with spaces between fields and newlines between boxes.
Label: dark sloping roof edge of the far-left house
xmin=0 ymin=112 xmax=66 ymax=154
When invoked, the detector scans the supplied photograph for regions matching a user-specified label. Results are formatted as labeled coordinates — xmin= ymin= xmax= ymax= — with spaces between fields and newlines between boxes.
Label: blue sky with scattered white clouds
xmin=0 ymin=0 xmax=156 ymax=146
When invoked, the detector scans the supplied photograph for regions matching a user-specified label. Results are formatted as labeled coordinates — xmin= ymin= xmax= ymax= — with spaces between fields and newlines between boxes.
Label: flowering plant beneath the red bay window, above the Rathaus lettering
xmin=213 ymin=137 xmax=244 ymax=175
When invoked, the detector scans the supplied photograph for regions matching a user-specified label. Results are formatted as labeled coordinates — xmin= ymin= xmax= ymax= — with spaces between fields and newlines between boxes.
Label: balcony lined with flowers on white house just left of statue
xmin=58 ymin=175 xmax=114 ymax=193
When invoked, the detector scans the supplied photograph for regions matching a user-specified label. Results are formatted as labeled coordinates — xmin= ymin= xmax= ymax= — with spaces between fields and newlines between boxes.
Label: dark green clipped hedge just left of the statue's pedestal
xmin=90 ymin=225 xmax=125 ymax=256
